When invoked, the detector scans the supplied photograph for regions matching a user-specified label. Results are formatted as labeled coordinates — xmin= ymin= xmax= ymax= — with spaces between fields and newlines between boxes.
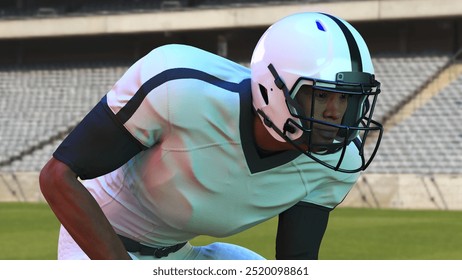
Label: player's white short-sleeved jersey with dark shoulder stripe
xmin=55 ymin=45 xmax=360 ymax=246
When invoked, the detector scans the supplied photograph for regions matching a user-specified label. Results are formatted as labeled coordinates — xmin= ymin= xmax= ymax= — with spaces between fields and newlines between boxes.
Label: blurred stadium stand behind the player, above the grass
xmin=0 ymin=0 xmax=462 ymax=210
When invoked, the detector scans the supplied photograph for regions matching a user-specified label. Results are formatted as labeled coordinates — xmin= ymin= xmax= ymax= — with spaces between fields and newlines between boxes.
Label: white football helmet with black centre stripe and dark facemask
xmin=250 ymin=12 xmax=383 ymax=173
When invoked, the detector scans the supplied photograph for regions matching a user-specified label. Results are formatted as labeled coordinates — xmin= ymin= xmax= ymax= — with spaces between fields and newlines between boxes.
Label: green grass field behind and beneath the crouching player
xmin=0 ymin=203 xmax=462 ymax=260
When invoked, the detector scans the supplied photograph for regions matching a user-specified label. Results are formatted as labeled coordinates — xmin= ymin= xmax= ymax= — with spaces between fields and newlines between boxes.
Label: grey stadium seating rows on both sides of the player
xmin=0 ymin=52 xmax=462 ymax=173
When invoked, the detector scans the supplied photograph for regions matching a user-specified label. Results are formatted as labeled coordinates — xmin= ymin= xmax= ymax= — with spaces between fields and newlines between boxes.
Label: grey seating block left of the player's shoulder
xmin=0 ymin=62 xmax=127 ymax=171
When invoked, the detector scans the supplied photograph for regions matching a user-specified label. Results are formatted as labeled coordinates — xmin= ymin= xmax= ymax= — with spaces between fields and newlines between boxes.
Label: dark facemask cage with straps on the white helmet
xmin=259 ymin=64 xmax=382 ymax=173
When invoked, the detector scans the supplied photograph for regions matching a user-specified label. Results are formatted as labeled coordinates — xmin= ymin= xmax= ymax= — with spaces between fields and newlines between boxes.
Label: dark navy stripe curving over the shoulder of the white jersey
xmin=116 ymin=68 xmax=240 ymax=123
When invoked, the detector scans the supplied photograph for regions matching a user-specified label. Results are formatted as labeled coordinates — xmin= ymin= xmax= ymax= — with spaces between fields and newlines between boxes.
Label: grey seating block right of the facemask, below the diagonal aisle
xmin=367 ymin=68 xmax=462 ymax=175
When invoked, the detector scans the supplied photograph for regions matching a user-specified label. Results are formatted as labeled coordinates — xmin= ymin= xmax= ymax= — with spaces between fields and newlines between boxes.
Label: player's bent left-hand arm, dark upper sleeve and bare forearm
xmin=40 ymin=99 xmax=147 ymax=259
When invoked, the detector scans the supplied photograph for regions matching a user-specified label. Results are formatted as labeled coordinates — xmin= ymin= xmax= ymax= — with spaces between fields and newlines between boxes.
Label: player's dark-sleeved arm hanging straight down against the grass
xmin=276 ymin=202 xmax=331 ymax=260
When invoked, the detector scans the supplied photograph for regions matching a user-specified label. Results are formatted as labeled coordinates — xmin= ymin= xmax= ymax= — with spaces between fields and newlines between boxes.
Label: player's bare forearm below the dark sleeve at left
xmin=40 ymin=159 xmax=130 ymax=259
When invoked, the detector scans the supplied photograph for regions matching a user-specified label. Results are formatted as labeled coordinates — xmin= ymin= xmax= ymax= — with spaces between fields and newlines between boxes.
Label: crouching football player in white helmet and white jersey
xmin=40 ymin=12 xmax=382 ymax=259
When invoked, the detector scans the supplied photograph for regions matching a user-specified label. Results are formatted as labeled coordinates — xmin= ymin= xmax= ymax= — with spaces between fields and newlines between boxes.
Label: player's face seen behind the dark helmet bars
xmin=297 ymin=86 xmax=348 ymax=150
